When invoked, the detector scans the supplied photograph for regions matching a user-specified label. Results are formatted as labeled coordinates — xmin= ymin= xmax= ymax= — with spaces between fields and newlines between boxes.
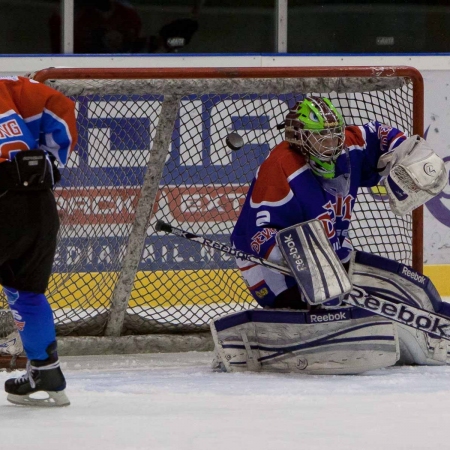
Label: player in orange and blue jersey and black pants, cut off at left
xmin=0 ymin=77 xmax=77 ymax=406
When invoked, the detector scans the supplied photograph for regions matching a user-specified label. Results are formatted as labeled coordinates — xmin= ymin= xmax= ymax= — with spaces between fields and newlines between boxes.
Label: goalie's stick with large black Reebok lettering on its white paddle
xmin=155 ymin=220 xmax=450 ymax=341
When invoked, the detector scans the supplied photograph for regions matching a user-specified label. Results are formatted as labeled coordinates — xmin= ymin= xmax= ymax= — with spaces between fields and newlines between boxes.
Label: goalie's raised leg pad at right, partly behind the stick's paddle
xmin=349 ymin=251 xmax=450 ymax=365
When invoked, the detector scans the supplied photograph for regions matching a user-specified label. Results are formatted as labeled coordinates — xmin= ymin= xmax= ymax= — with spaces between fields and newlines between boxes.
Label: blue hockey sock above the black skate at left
xmin=3 ymin=286 xmax=56 ymax=360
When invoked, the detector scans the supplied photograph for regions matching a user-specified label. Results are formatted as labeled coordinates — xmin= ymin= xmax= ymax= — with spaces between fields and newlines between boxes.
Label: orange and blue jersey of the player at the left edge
xmin=0 ymin=77 xmax=77 ymax=165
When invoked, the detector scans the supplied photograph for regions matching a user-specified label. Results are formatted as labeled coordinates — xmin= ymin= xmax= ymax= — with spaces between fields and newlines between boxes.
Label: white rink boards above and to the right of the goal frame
xmin=0 ymin=54 xmax=450 ymax=286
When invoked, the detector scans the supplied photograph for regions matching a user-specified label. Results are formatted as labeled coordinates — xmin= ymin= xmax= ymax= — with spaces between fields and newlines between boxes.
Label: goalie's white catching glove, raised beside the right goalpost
xmin=378 ymin=135 xmax=448 ymax=216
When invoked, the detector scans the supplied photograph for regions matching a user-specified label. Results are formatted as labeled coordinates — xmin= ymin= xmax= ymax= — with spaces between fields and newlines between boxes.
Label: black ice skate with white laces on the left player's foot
xmin=5 ymin=342 xmax=70 ymax=406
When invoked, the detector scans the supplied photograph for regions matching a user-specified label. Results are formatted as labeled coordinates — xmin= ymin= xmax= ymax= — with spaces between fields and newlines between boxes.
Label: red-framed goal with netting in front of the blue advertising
xmin=0 ymin=67 xmax=423 ymax=352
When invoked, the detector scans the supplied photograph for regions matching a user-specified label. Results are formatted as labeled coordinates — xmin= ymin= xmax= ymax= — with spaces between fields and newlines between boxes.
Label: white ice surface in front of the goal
xmin=0 ymin=352 xmax=450 ymax=450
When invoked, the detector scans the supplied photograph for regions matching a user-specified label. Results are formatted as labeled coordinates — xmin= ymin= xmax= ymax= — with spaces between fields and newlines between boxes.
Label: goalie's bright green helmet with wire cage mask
xmin=285 ymin=97 xmax=344 ymax=179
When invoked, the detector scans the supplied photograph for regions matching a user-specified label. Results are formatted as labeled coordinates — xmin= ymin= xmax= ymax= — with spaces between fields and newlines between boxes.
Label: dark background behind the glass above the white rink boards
xmin=0 ymin=0 xmax=450 ymax=54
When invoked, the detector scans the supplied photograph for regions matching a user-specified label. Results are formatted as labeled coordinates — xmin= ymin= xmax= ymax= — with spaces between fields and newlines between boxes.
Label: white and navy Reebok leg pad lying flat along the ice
xmin=211 ymin=308 xmax=399 ymax=375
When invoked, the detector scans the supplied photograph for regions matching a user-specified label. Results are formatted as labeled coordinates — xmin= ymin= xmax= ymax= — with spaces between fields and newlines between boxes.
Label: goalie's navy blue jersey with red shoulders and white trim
xmin=231 ymin=122 xmax=406 ymax=306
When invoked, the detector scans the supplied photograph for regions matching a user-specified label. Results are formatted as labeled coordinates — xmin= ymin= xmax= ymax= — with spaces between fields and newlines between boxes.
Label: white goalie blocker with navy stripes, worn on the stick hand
xmin=276 ymin=219 xmax=352 ymax=305
